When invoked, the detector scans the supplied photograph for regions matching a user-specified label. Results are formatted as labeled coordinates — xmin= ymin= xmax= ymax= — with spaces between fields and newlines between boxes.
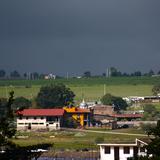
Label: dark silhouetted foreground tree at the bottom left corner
xmin=0 ymin=91 xmax=52 ymax=160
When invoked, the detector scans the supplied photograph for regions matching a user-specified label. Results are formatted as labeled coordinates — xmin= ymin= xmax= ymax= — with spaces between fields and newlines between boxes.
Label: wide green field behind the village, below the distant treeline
xmin=0 ymin=77 xmax=160 ymax=101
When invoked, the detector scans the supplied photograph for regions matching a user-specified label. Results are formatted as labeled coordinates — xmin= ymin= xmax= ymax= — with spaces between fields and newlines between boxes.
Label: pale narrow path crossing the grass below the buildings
xmin=64 ymin=128 xmax=148 ymax=137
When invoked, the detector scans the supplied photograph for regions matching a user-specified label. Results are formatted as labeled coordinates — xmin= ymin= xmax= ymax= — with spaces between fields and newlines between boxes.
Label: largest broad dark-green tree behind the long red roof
xmin=36 ymin=84 xmax=75 ymax=108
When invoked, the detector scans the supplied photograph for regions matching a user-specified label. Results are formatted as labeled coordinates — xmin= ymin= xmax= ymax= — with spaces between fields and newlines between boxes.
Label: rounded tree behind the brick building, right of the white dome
xmin=101 ymin=93 xmax=128 ymax=111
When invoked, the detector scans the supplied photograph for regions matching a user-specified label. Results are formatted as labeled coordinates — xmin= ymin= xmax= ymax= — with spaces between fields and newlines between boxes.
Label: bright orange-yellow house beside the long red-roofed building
xmin=63 ymin=107 xmax=91 ymax=127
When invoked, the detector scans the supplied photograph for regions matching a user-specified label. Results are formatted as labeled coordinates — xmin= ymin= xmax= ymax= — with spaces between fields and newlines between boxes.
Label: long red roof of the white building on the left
xmin=18 ymin=109 xmax=64 ymax=116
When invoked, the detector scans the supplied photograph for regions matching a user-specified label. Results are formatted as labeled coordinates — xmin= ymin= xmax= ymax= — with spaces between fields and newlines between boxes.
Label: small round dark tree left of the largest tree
xmin=12 ymin=97 xmax=32 ymax=110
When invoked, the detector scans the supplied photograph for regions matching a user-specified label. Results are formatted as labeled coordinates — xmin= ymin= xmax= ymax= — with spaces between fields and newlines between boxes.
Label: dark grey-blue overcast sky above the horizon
xmin=0 ymin=0 xmax=160 ymax=75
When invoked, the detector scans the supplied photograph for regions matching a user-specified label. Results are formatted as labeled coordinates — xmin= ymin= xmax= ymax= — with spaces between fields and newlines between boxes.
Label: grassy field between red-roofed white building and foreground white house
xmin=12 ymin=129 xmax=143 ymax=150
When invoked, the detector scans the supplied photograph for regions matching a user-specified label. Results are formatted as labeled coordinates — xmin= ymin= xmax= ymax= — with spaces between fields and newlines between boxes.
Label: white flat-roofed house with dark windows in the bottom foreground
xmin=98 ymin=139 xmax=147 ymax=160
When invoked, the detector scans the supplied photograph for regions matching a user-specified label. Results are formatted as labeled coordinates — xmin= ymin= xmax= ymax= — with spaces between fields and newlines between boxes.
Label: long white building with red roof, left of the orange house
xmin=17 ymin=109 xmax=64 ymax=130
